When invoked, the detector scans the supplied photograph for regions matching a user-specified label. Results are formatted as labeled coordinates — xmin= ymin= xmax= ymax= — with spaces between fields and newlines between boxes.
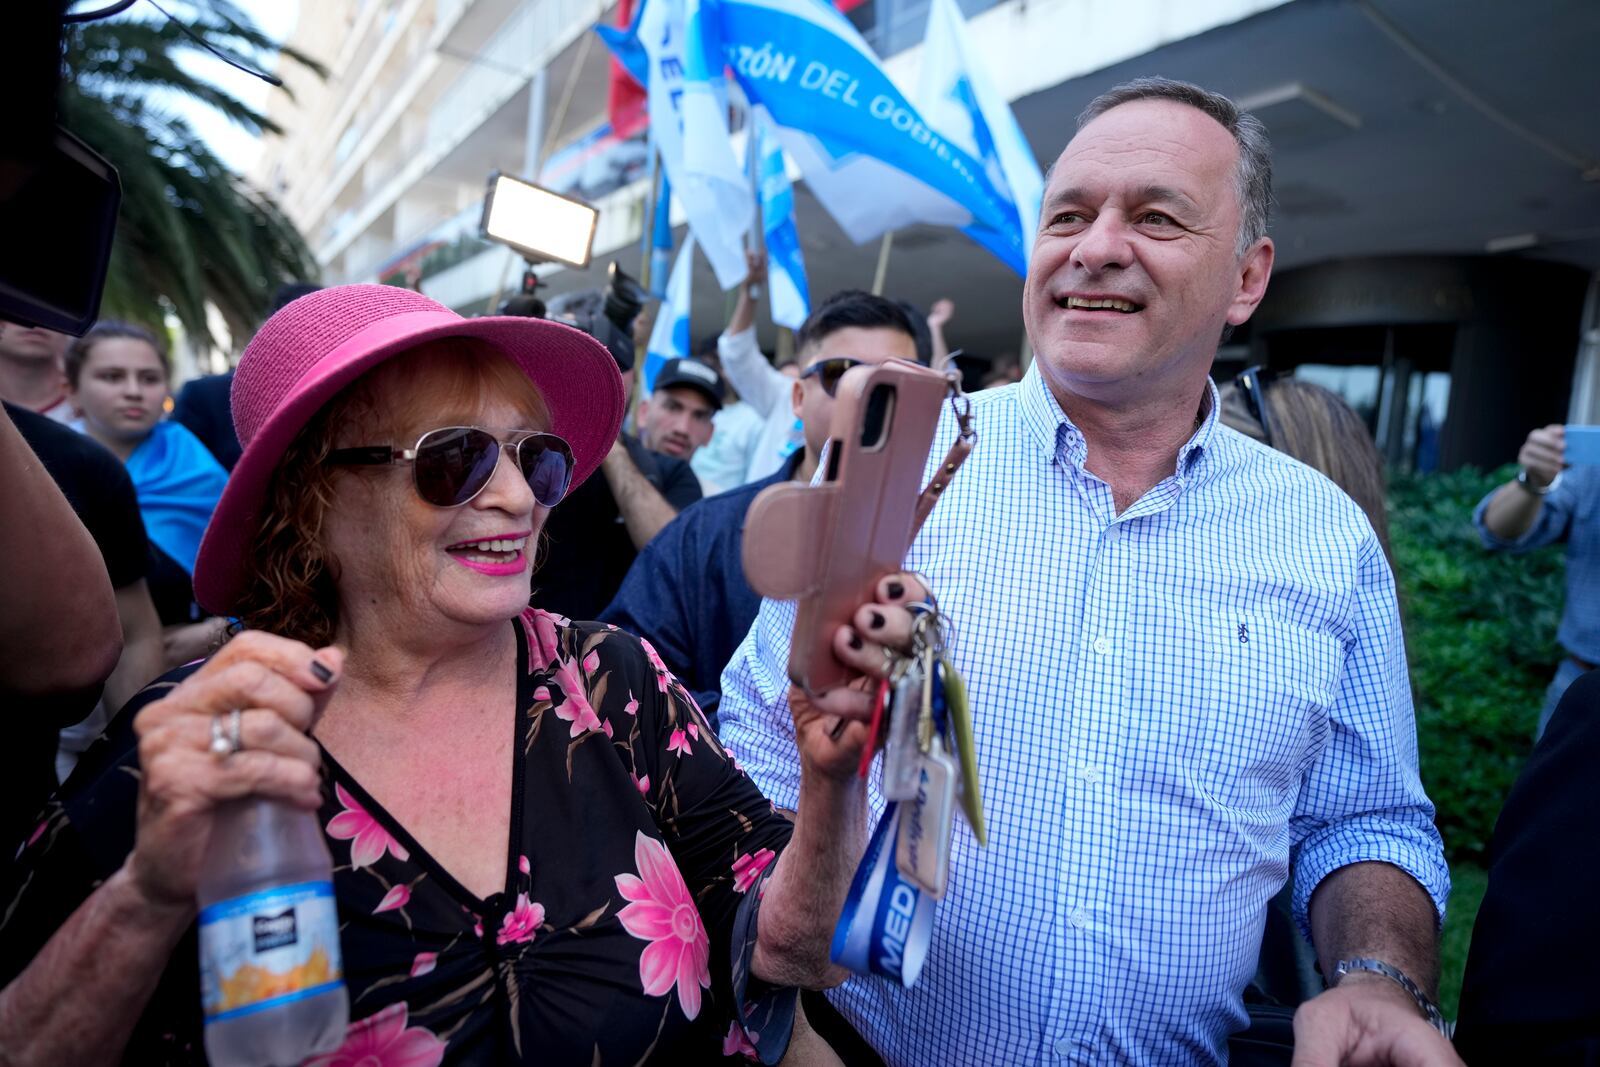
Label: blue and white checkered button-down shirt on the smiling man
xmin=722 ymin=366 xmax=1450 ymax=1065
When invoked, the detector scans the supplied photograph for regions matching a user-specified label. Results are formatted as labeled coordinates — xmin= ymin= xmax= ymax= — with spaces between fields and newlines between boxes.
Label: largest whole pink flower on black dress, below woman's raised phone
xmin=616 ymin=830 xmax=710 ymax=1019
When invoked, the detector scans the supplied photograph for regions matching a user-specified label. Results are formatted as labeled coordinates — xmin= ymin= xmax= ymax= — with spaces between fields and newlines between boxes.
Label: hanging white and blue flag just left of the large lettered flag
xmin=619 ymin=0 xmax=755 ymax=290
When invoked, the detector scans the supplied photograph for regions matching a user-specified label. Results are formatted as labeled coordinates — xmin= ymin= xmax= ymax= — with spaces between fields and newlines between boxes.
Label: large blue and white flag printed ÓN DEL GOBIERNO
xmin=713 ymin=0 xmax=1032 ymax=274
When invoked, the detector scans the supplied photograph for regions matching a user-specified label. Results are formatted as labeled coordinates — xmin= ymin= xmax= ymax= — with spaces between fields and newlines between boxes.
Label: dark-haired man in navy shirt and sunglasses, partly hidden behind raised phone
xmin=600 ymin=290 xmax=920 ymax=725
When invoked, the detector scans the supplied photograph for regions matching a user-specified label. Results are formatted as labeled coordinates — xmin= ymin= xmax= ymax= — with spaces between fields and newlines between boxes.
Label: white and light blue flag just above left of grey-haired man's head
xmin=917 ymin=0 xmax=1045 ymax=272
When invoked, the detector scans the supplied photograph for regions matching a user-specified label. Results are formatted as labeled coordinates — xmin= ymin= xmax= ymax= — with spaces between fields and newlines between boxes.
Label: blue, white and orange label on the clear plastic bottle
xmin=200 ymin=881 xmax=344 ymax=1024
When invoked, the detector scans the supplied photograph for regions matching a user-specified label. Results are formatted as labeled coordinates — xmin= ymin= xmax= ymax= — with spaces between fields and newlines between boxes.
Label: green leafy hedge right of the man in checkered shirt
xmin=1389 ymin=467 xmax=1565 ymax=865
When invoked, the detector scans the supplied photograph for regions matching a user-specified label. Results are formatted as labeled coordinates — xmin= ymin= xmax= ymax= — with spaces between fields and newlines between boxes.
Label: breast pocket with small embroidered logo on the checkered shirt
xmin=1190 ymin=611 xmax=1344 ymax=817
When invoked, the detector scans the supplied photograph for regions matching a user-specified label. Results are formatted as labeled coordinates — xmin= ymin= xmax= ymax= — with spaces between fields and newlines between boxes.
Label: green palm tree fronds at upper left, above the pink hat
xmin=61 ymin=0 xmax=325 ymax=346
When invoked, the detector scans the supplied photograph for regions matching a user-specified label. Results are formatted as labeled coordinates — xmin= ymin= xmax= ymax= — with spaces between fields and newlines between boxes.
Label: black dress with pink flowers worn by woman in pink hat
xmin=0 ymin=609 xmax=794 ymax=1067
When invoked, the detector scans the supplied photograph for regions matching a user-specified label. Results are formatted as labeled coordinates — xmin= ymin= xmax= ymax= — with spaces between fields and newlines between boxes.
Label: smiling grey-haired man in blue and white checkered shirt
xmin=722 ymin=80 xmax=1459 ymax=1064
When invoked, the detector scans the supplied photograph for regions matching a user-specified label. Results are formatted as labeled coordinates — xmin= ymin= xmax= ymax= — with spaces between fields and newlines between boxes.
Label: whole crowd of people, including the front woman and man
xmin=0 ymin=78 xmax=1600 ymax=1065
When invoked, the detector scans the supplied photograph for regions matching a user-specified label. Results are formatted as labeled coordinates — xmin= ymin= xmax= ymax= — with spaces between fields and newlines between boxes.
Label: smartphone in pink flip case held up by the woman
xmin=742 ymin=360 xmax=950 ymax=696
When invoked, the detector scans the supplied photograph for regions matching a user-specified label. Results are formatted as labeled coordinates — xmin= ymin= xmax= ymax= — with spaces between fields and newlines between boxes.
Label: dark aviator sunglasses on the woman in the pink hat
xmin=328 ymin=426 xmax=573 ymax=507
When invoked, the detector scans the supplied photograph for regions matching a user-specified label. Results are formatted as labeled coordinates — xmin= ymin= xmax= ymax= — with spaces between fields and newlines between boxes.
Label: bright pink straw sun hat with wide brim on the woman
xmin=194 ymin=285 xmax=622 ymax=614
